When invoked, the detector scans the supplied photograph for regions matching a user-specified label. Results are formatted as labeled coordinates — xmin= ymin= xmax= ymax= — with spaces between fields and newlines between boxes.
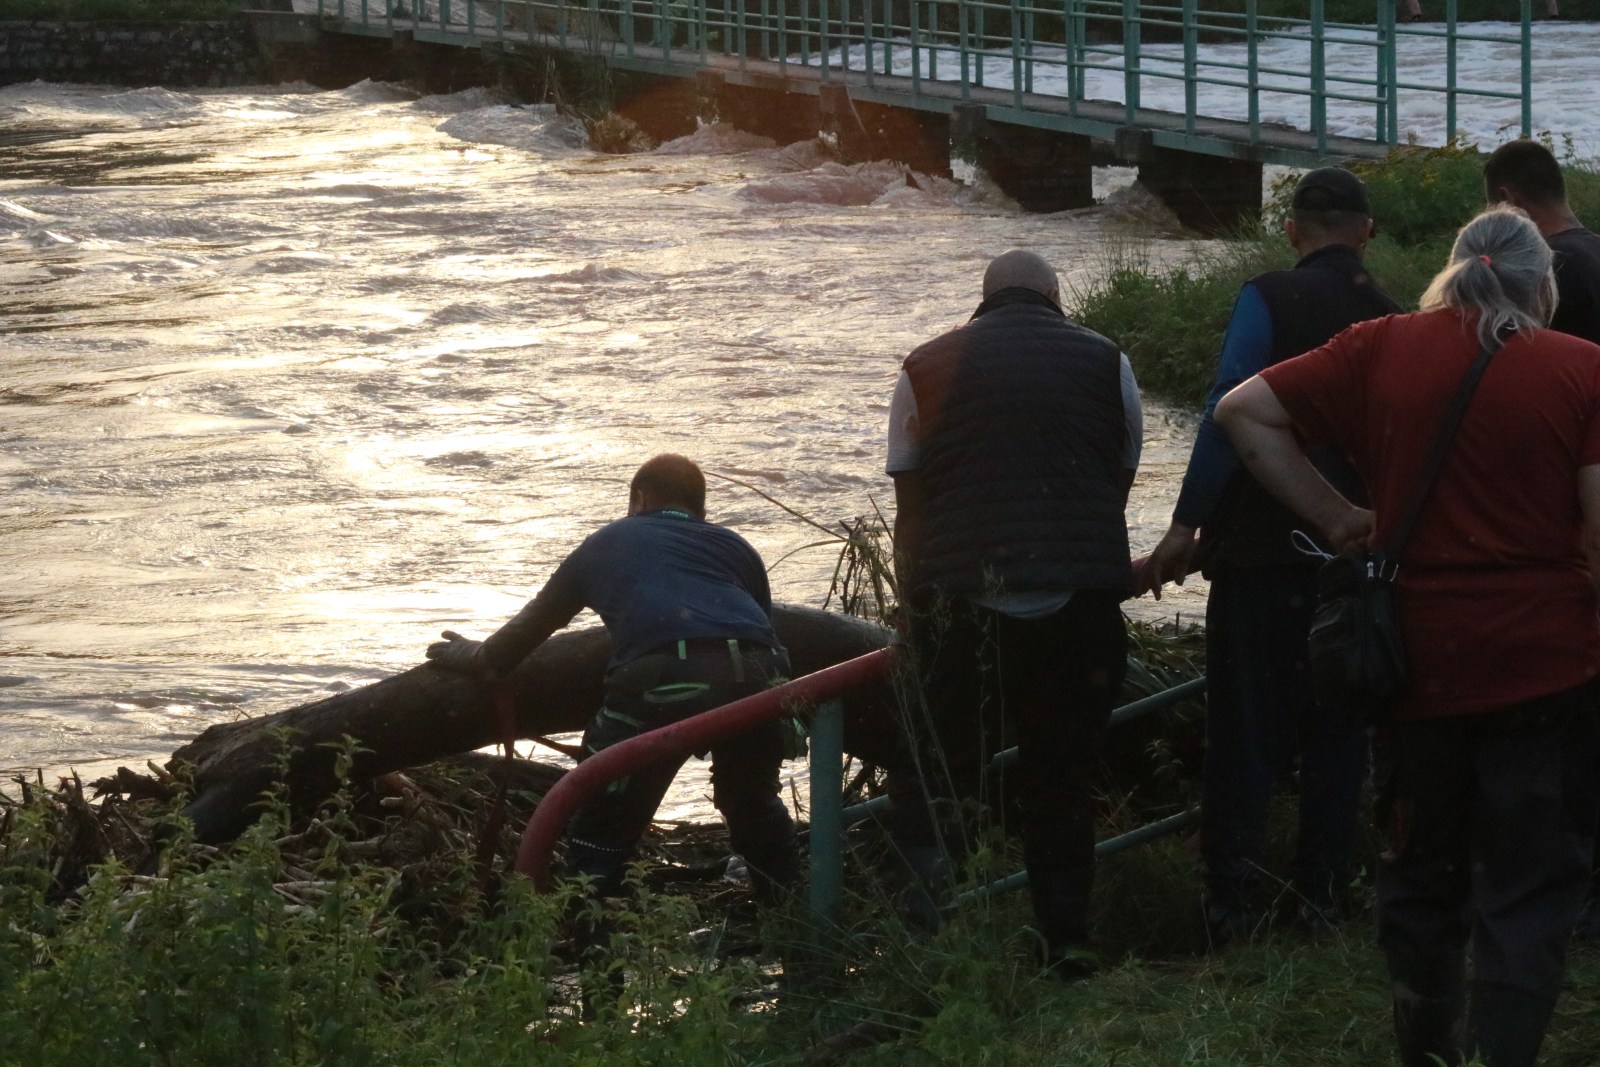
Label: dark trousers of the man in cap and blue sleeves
xmin=1200 ymin=566 xmax=1366 ymax=907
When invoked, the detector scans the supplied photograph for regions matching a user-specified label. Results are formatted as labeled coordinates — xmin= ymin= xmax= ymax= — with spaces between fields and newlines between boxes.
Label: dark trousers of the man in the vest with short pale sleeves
xmin=902 ymin=590 xmax=1128 ymax=949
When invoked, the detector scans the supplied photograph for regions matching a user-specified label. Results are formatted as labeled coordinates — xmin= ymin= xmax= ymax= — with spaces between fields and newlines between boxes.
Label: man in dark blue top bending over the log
xmin=427 ymin=454 xmax=798 ymax=959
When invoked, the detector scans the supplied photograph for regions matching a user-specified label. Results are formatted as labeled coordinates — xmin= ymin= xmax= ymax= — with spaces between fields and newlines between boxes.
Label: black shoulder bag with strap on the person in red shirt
xmin=1307 ymin=338 xmax=1501 ymax=725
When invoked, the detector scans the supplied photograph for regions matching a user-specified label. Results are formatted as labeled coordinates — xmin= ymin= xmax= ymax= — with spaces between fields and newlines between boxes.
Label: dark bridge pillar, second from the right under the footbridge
xmin=950 ymin=104 xmax=1094 ymax=211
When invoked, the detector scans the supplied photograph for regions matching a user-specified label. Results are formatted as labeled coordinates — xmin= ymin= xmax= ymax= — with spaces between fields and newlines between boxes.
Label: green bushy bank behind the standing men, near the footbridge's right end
xmin=1067 ymin=144 xmax=1600 ymax=405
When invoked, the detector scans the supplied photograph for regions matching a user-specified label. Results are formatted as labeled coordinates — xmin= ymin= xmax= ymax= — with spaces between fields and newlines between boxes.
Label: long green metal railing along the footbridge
xmin=318 ymin=0 xmax=1533 ymax=162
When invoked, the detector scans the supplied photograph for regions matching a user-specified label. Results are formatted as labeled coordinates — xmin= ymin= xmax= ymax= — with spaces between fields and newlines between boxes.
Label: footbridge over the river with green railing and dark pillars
xmin=272 ymin=0 xmax=1531 ymax=229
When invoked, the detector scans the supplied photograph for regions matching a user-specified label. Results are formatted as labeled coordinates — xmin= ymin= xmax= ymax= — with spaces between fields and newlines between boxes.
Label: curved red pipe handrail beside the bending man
xmin=517 ymin=649 xmax=893 ymax=888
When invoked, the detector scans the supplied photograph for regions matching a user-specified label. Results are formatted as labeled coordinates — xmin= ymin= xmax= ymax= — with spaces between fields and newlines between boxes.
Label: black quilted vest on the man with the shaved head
xmin=906 ymin=290 xmax=1130 ymax=597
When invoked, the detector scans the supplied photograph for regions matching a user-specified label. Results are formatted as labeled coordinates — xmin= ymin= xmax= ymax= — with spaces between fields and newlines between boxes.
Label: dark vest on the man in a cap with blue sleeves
xmin=1200 ymin=245 xmax=1402 ymax=576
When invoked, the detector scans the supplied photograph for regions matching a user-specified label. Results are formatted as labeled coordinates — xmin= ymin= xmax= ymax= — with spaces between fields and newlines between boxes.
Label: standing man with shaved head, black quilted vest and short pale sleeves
xmin=886 ymin=251 xmax=1142 ymax=977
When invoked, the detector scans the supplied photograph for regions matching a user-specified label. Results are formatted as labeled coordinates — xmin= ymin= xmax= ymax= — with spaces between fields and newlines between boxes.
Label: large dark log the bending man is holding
xmin=166 ymin=605 xmax=896 ymax=841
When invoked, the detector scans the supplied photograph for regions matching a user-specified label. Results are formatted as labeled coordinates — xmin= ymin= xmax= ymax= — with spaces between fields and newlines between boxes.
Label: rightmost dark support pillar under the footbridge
xmin=1117 ymin=128 xmax=1261 ymax=235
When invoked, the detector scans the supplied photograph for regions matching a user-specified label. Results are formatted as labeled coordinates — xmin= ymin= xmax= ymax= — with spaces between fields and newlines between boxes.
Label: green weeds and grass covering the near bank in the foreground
xmin=9 ymin=758 xmax=1600 ymax=1067
